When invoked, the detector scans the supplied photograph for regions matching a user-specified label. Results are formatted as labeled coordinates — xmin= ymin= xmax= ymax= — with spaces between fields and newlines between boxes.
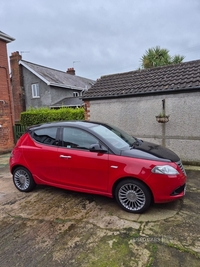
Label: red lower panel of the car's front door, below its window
xmin=58 ymin=147 xmax=109 ymax=192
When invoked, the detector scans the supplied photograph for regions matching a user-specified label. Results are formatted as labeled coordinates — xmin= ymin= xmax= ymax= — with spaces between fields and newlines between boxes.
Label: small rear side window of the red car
xmin=32 ymin=127 xmax=58 ymax=145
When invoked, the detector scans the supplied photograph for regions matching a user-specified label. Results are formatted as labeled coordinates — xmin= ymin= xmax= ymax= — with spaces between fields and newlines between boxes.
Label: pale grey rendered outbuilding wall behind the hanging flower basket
xmin=90 ymin=92 xmax=200 ymax=164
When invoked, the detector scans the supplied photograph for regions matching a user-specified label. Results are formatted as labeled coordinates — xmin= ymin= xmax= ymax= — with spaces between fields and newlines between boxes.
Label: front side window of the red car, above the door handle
xmin=63 ymin=127 xmax=99 ymax=150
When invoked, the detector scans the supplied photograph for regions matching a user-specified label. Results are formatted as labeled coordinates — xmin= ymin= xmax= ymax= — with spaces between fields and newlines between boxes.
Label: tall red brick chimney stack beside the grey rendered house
xmin=10 ymin=51 xmax=26 ymax=122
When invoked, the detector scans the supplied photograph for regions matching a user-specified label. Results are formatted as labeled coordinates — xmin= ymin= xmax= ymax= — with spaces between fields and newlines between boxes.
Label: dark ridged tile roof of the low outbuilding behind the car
xmin=83 ymin=60 xmax=200 ymax=100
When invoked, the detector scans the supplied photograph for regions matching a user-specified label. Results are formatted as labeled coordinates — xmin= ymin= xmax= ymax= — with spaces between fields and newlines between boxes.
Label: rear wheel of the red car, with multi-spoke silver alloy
xmin=13 ymin=167 xmax=36 ymax=192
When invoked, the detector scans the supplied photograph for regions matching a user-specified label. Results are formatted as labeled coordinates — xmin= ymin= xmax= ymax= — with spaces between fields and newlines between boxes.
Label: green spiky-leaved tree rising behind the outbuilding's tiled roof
xmin=141 ymin=46 xmax=185 ymax=69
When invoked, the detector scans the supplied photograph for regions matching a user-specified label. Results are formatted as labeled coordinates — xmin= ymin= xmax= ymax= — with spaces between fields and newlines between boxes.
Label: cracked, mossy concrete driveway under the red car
xmin=0 ymin=154 xmax=200 ymax=267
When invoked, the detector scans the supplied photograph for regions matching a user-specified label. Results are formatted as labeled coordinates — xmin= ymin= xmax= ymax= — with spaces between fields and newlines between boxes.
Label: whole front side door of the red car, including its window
xmin=58 ymin=127 xmax=109 ymax=192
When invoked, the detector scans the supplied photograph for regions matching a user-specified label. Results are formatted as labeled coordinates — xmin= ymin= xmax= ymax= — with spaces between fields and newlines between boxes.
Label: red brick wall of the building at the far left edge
xmin=0 ymin=40 xmax=14 ymax=153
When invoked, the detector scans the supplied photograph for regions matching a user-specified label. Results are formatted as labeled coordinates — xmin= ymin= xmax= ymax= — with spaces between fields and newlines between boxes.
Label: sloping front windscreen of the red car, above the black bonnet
xmin=90 ymin=125 xmax=136 ymax=149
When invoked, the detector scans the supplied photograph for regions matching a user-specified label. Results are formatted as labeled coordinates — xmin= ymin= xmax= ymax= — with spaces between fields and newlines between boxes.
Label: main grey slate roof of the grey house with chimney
xmin=19 ymin=60 xmax=95 ymax=90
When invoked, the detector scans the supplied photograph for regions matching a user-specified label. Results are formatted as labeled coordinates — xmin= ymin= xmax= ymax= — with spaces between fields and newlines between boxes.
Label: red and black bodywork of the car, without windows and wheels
xmin=10 ymin=122 xmax=187 ymax=207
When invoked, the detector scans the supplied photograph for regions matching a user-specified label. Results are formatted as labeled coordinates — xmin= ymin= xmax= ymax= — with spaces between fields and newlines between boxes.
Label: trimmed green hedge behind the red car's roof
xmin=21 ymin=107 xmax=84 ymax=126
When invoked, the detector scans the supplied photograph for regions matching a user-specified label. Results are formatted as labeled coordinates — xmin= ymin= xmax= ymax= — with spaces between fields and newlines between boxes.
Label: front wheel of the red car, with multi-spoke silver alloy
xmin=115 ymin=179 xmax=152 ymax=213
